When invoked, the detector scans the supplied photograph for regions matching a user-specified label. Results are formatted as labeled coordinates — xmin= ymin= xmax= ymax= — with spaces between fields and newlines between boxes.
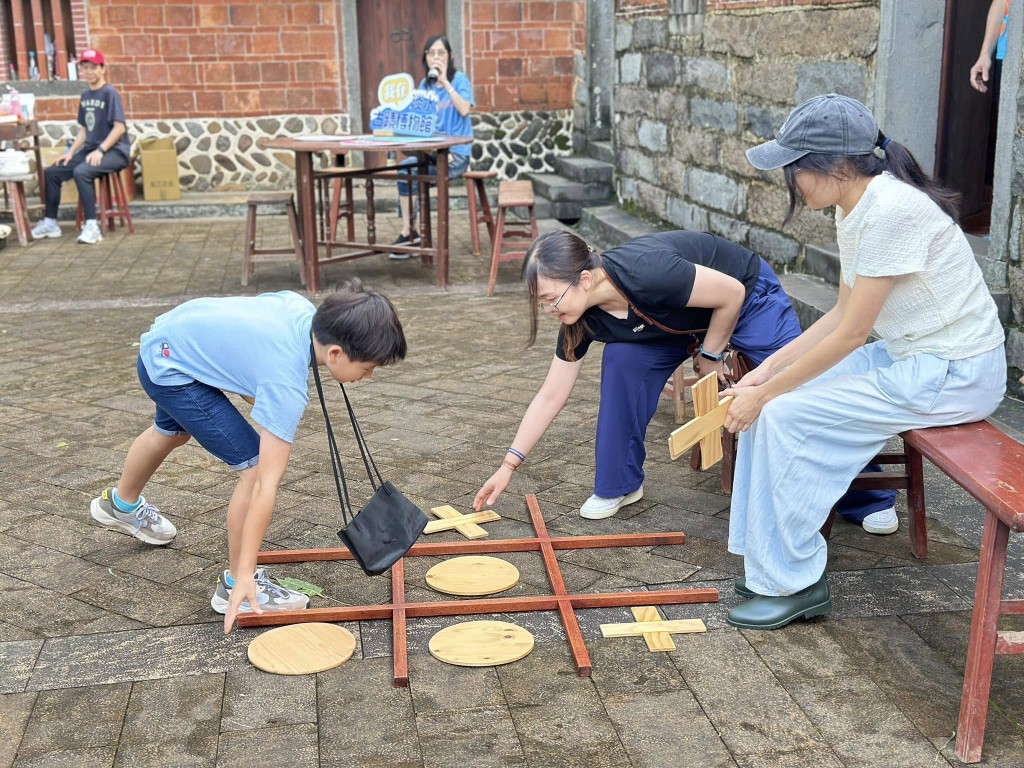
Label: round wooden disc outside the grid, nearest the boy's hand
xmin=249 ymin=623 xmax=355 ymax=675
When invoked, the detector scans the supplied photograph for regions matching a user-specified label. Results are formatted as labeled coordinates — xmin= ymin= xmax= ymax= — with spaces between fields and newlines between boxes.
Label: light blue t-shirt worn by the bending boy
xmin=139 ymin=291 xmax=316 ymax=442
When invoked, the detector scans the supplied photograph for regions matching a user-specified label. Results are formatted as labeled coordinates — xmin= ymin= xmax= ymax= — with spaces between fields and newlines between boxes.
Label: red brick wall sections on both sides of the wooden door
xmin=37 ymin=0 xmax=585 ymax=120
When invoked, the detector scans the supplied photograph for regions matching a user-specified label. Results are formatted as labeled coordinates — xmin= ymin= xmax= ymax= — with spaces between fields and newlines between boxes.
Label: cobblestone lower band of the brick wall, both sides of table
xmin=32 ymin=110 xmax=572 ymax=193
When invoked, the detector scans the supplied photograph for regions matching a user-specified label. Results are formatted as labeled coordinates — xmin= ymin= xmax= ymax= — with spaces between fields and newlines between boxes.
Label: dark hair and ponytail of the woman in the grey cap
xmin=782 ymin=131 xmax=961 ymax=225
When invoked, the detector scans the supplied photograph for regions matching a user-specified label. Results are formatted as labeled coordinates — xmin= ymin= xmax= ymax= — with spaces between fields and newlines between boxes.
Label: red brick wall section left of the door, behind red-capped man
xmin=33 ymin=0 xmax=346 ymax=119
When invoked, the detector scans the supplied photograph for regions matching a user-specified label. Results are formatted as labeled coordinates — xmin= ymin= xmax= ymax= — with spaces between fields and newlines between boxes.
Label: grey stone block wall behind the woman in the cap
xmin=614 ymin=0 xmax=879 ymax=270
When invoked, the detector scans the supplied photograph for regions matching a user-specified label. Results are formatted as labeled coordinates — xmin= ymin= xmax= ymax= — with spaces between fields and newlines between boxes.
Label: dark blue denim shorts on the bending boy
xmin=136 ymin=356 xmax=259 ymax=470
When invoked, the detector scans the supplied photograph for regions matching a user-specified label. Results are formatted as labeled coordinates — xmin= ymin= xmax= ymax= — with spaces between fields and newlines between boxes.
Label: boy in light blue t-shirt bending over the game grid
xmin=90 ymin=280 xmax=406 ymax=634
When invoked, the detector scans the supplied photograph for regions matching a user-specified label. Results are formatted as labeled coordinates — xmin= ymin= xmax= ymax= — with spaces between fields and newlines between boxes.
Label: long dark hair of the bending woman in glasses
xmin=522 ymin=229 xmax=601 ymax=361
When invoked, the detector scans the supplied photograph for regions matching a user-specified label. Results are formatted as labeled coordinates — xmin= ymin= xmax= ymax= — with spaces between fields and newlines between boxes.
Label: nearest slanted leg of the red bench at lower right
xmin=956 ymin=512 xmax=1010 ymax=763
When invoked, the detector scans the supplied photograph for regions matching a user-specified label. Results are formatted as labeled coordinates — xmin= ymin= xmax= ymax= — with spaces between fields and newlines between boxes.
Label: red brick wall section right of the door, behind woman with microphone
xmin=465 ymin=0 xmax=587 ymax=112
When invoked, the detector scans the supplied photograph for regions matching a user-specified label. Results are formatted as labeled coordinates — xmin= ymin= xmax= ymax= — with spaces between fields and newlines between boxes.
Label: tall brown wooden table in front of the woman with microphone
xmin=260 ymin=136 xmax=473 ymax=293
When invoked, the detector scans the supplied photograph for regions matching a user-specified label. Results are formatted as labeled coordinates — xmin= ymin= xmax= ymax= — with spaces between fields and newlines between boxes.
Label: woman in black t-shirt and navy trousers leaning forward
xmin=474 ymin=231 xmax=801 ymax=519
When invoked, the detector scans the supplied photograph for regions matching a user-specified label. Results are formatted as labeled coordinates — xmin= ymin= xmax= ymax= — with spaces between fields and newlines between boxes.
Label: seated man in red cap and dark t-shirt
xmin=32 ymin=48 xmax=130 ymax=245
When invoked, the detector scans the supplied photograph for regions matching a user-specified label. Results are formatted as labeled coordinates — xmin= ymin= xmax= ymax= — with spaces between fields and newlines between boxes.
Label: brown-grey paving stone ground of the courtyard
xmin=0 ymin=216 xmax=1024 ymax=768
